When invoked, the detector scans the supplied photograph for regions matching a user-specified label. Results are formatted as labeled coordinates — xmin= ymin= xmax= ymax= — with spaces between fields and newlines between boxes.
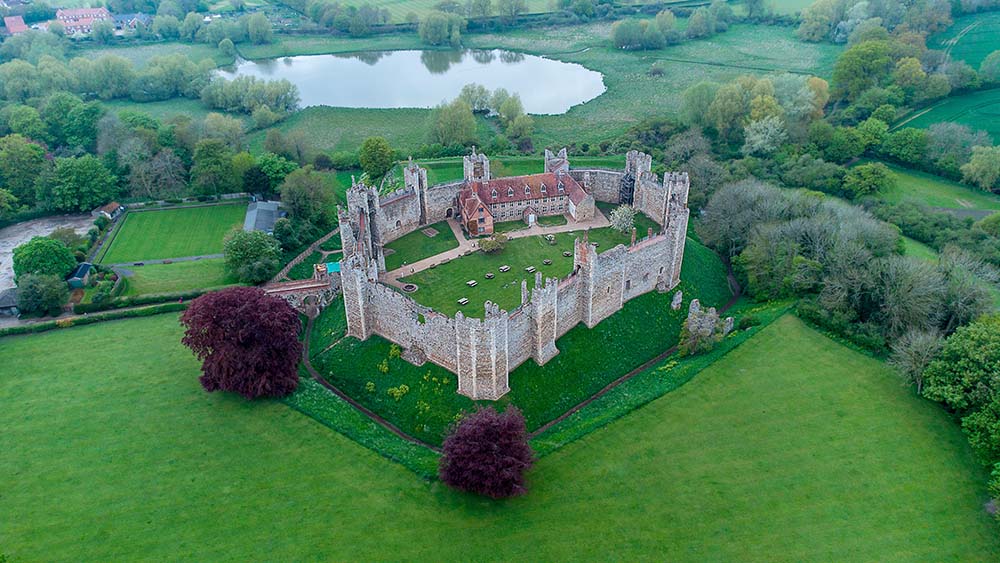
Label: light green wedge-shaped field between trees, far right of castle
xmin=868 ymin=163 xmax=1000 ymax=214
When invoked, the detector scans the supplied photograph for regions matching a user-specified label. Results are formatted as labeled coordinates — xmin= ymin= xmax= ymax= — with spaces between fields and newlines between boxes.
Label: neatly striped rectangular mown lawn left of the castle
xmin=101 ymin=204 xmax=247 ymax=264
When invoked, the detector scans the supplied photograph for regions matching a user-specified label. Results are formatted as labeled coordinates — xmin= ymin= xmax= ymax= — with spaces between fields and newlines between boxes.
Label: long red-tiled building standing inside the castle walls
xmin=458 ymin=150 xmax=594 ymax=236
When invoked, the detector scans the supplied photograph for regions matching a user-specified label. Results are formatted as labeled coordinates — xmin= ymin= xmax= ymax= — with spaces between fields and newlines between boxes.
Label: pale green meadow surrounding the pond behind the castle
xmin=241 ymin=21 xmax=842 ymax=154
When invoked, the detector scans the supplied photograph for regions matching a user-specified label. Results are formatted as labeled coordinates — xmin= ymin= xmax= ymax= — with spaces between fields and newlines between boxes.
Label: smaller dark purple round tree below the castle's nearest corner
xmin=439 ymin=406 xmax=534 ymax=498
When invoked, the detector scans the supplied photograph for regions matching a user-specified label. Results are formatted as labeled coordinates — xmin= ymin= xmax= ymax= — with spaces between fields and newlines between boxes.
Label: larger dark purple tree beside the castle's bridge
xmin=181 ymin=287 xmax=302 ymax=399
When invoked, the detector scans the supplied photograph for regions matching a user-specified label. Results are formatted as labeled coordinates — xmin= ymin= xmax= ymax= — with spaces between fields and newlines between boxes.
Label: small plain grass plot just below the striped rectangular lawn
xmin=122 ymin=258 xmax=238 ymax=295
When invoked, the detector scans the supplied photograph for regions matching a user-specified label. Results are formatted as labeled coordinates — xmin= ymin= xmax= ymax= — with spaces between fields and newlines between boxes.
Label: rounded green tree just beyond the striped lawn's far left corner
xmin=49 ymin=154 xmax=118 ymax=211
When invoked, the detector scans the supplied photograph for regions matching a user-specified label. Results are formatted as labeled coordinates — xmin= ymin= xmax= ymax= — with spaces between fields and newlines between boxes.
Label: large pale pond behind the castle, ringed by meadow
xmin=219 ymin=50 xmax=606 ymax=114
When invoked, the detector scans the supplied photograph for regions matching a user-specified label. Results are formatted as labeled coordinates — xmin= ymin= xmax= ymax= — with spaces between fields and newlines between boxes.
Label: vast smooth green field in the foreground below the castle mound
xmin=0 ymin=315 xmax=1000 ymax=562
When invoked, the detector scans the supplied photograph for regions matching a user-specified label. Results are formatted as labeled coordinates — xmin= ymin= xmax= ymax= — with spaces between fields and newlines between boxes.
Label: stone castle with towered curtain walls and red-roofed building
xmin=339 ymin=149 xmax=689 ymax=400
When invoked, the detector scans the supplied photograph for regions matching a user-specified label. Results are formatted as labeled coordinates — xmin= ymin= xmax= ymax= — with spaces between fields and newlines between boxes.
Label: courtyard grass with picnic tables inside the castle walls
xmin=398 ymin=223 xmax=664 ymax=317
